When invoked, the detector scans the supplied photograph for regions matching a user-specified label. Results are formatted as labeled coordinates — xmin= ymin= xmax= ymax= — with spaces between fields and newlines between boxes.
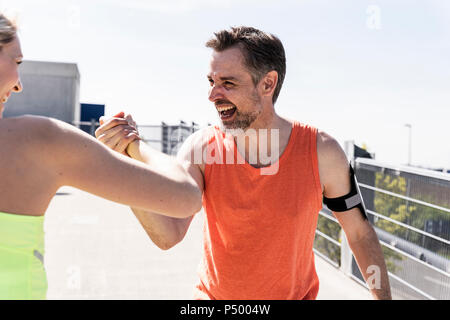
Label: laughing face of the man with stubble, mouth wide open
xmin=207 ymin=48 xmax=262 ymax=130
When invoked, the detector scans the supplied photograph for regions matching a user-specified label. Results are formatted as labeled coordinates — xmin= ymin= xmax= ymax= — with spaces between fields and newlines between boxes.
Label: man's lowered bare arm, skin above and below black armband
xmin=317 ymin=132 xmax=392 ymax=299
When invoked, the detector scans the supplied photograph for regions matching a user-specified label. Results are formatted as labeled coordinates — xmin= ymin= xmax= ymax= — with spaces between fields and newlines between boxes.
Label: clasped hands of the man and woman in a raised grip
xmin=95 ymin=112 xmax=140 ymax=156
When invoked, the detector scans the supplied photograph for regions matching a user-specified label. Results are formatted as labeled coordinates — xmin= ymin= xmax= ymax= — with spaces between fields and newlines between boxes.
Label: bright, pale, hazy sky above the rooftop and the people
xmin=0 ymin=0 xmax=450 ymax=168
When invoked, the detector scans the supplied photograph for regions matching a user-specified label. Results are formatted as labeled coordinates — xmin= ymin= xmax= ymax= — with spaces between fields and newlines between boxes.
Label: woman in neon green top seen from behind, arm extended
xmin=0 ymin=13 xmax=201 ymax=299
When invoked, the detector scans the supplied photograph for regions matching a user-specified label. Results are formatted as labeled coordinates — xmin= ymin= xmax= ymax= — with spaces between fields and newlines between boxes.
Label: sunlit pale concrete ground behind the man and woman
xmin=45 ymin=187 xmax=371 ymax=300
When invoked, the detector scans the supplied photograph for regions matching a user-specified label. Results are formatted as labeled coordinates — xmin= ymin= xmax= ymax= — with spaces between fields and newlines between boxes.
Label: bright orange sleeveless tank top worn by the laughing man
xmin=194 ymin=122 xmax=322 ymax=300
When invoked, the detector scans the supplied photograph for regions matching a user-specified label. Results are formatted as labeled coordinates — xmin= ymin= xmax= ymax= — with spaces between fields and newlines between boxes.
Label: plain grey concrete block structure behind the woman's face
xmin=4 ymin=61 xmax=80 ymax=122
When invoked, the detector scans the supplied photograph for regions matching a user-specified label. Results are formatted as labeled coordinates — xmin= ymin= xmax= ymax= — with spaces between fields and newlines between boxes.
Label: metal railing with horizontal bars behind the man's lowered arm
xmin=314 ymin=152 xmax=450 ymax=300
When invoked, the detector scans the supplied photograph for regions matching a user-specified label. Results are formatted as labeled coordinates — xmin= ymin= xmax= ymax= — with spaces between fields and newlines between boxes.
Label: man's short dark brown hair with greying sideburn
xmin=206 ymin=26 xmax=286 ymax=104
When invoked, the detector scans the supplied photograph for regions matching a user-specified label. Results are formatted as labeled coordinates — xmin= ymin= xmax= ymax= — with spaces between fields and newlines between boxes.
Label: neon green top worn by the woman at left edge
xmin=0 ymin=212 xmax=47 ymax=300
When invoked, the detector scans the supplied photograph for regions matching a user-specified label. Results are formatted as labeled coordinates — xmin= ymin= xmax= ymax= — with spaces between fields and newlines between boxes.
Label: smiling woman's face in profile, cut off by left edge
xmin=0 ymin=37 xmax=23 ymax=119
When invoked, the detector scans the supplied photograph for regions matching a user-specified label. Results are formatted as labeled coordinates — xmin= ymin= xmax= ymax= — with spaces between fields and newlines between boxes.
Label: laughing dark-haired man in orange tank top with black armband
xmin=96 ymin=27 xmax=391 ymax=299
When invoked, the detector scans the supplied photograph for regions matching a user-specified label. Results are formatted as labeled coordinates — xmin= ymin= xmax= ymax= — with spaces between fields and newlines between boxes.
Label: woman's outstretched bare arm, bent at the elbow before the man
xmin=33 ymin=117 xmax=202 ymax=218
